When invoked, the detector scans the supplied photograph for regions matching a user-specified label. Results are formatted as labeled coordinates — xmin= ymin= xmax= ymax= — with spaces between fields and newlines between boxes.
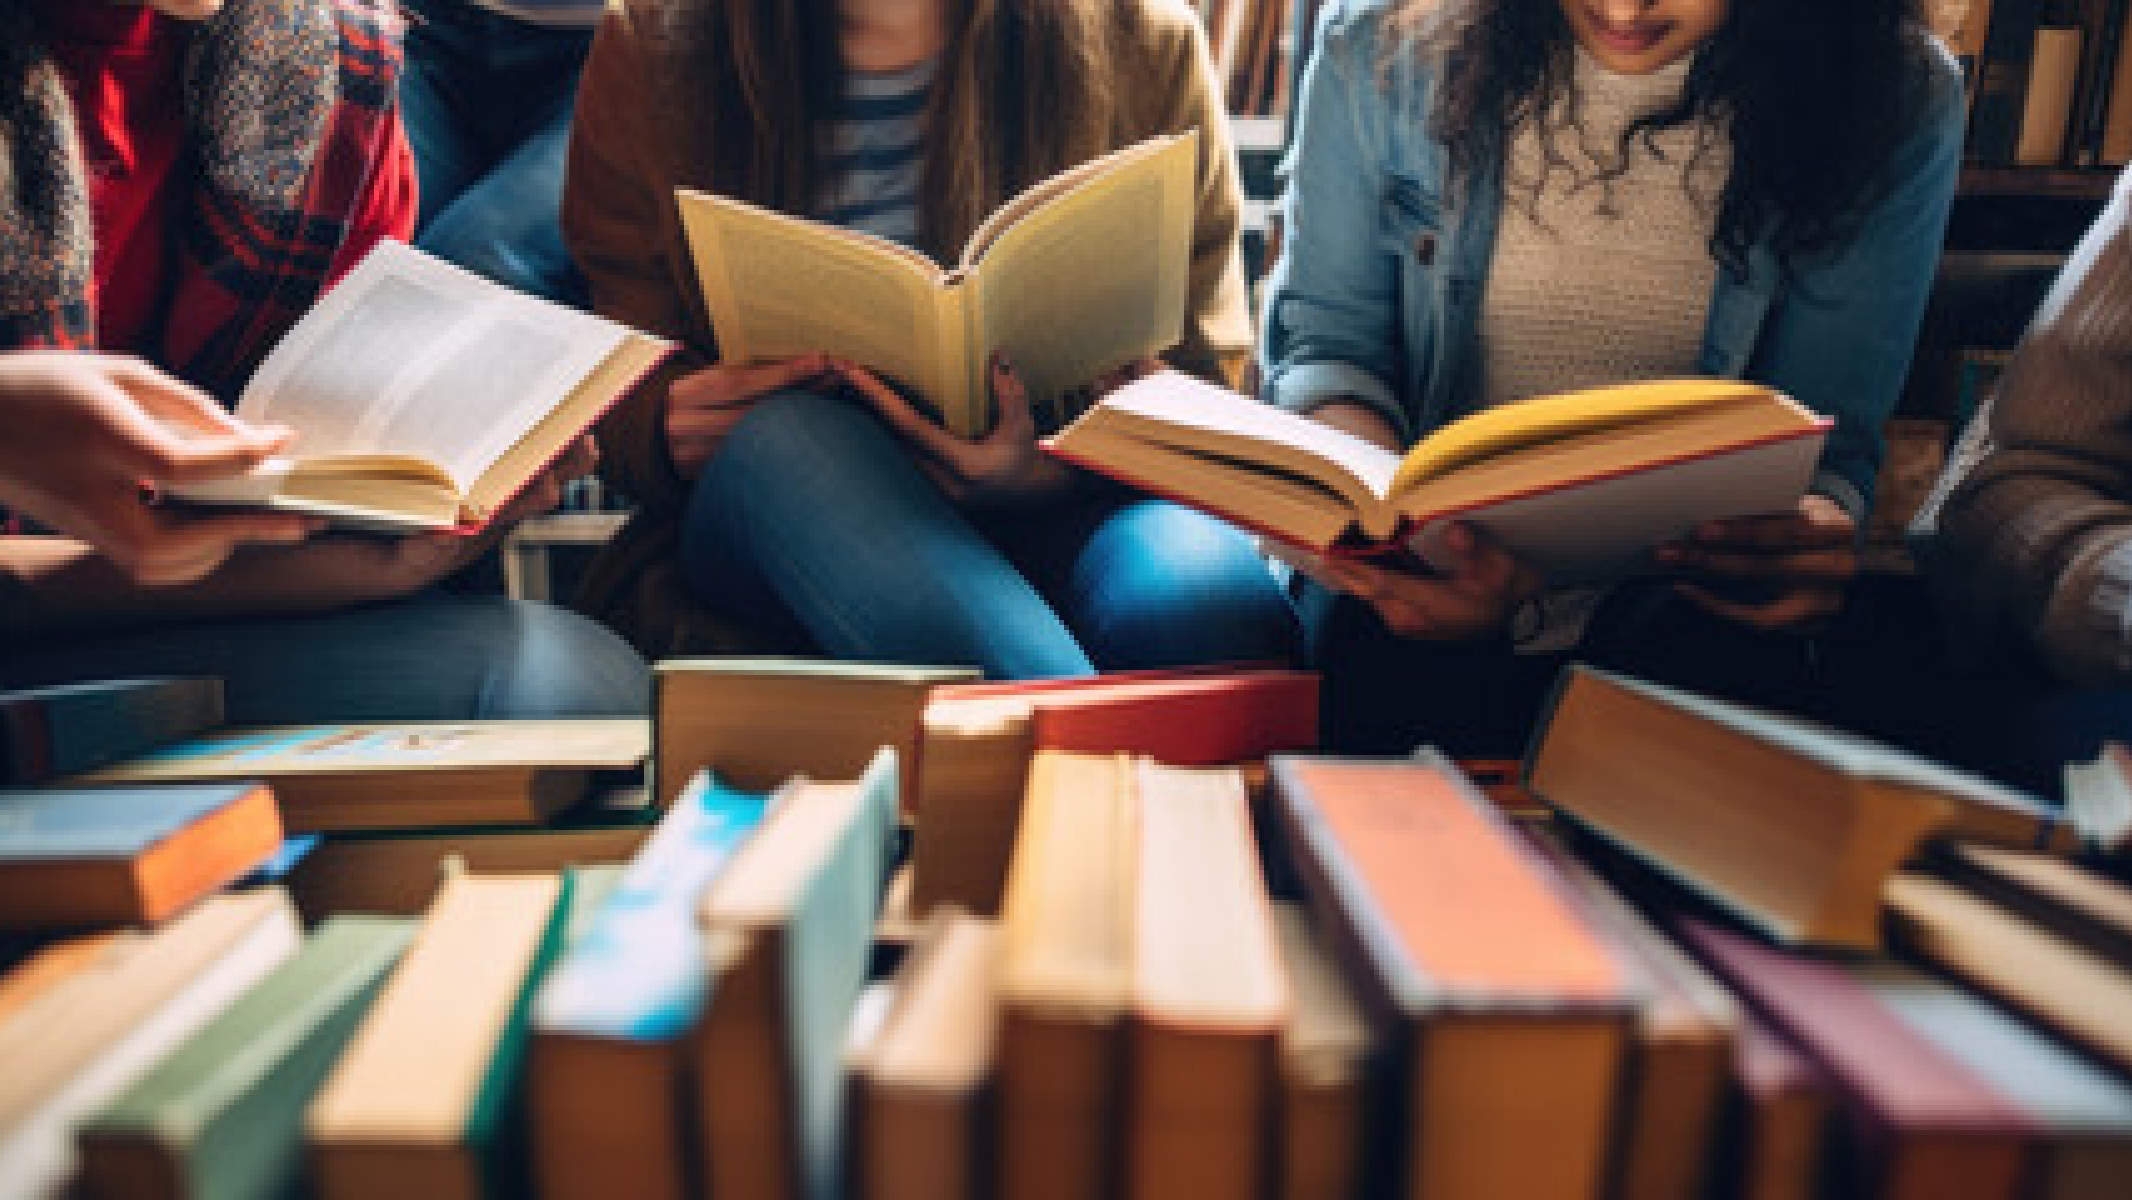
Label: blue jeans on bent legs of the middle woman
xmin=682 ymin=392 xmax=1296 ymax=680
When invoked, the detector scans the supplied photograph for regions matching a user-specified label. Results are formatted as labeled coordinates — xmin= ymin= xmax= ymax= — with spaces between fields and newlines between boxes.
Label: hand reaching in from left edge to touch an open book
xmin=0 ymin=350 xmax=311 ymax=584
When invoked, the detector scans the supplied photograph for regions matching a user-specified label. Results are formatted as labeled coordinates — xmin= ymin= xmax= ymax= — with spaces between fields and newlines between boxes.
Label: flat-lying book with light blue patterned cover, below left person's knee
xmin=75 ymin=718 xmax=650 ymax=833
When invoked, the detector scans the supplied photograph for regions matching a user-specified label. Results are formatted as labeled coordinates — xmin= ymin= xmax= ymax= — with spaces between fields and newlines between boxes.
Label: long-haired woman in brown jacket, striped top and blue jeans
xmin=563 ymin=0 xmax=1294 ymax=678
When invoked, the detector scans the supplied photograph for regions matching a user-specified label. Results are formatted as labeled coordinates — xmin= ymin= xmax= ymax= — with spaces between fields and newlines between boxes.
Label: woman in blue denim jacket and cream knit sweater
xmin=1262 ymin=0 xmax=1961 ymax=752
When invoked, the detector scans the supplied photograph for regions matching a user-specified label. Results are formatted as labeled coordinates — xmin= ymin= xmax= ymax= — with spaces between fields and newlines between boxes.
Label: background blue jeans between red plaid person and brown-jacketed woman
xmin=401 ymin=0 xmax=593 ymax=305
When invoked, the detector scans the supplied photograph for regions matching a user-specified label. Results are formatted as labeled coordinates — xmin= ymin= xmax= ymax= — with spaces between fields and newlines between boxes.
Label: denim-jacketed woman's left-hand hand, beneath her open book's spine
xmin=1296 ymin=522 xmax=1539 ymax=642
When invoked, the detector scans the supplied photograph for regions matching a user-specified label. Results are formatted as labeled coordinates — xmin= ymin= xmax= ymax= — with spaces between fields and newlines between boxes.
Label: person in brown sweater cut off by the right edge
xmin=1912 ymin=161 xmax=2132 ymax=793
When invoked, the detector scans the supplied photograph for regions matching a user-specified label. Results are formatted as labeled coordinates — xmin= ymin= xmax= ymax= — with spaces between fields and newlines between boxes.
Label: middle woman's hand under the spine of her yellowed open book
xmin=836 ymin=354 xmax=1075 ymax=507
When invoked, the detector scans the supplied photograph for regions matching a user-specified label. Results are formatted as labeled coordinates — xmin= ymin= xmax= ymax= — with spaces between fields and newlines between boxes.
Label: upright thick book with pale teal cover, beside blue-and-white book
xmin=693 ymin=748 xmax=898 ymax=1200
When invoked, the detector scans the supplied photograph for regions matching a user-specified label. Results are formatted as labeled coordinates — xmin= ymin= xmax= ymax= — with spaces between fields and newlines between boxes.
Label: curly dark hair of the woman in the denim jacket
xmin=1388 ymin=0 xmax=1936 ymax=273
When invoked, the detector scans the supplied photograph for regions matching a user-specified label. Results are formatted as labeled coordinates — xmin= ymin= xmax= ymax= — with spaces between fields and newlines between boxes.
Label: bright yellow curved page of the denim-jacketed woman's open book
xmin=1392 ymin=379 xmax=1772 ymax=494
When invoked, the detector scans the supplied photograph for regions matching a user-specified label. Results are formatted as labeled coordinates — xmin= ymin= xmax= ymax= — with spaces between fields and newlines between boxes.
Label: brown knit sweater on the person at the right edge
xmin=1917 ymin=173 xmax=2132 ymax=684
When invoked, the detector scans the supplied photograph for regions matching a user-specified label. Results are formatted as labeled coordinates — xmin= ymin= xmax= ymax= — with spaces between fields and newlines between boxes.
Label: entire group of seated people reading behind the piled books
xmin=0 ymin=0 xmax=2132 ymax=797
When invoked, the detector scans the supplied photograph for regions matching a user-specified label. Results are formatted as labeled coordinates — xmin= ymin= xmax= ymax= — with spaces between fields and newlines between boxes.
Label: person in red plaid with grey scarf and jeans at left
xmin=0 ymin=0 xmax=648 ymax=723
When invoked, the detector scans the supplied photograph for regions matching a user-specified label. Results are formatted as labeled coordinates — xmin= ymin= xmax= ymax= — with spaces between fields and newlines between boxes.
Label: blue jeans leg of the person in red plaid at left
xmin=0 ymin=593 xmax=650 ymax=725
